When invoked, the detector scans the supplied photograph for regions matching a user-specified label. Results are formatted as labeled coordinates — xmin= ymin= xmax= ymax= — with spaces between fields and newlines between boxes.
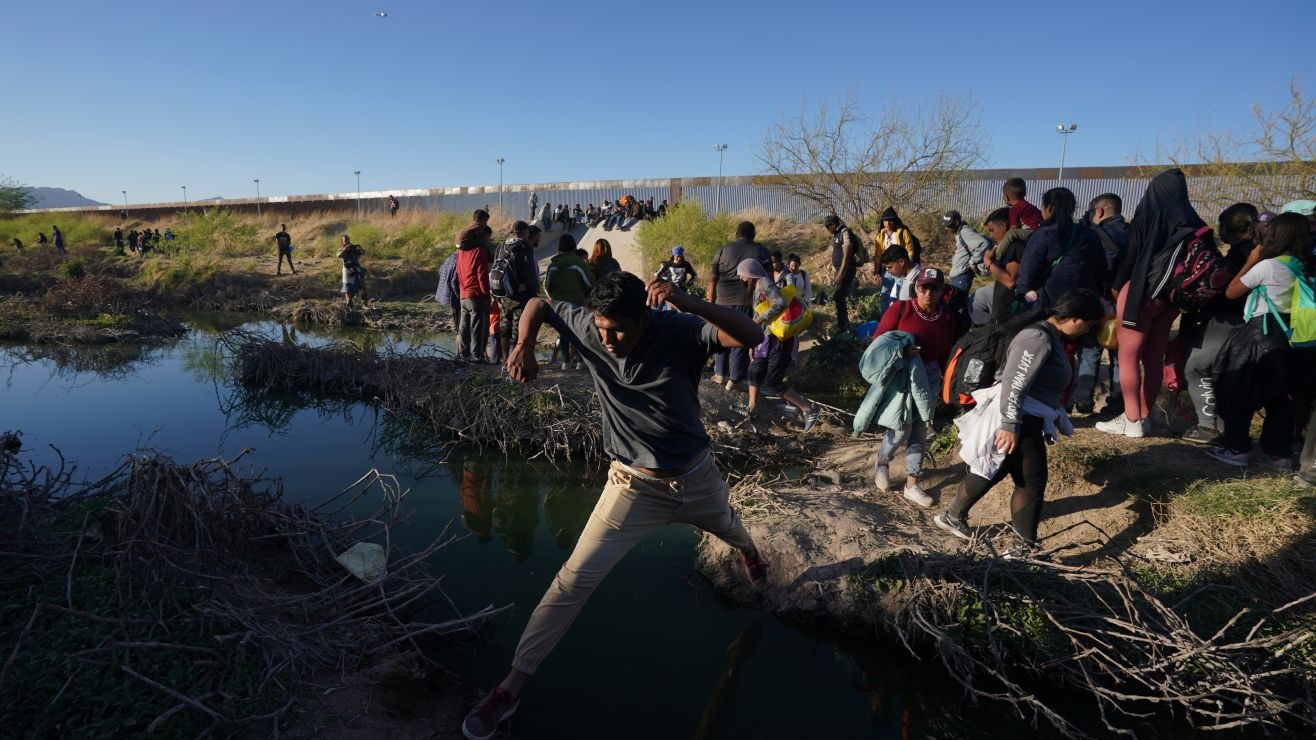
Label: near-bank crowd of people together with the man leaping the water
xmin=444 ymin=170 xmax=1316 ymax=739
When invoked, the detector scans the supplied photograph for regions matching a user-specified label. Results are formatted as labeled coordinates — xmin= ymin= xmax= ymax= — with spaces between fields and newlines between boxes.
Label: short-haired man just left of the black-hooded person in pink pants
xmin=1074 ymin=192 xmax=1129 ymax=416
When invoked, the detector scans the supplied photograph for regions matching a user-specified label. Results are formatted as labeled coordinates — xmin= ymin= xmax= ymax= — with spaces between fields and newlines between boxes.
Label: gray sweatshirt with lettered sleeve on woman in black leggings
xmin=996 ymin=321 xmax=1074 ymax=433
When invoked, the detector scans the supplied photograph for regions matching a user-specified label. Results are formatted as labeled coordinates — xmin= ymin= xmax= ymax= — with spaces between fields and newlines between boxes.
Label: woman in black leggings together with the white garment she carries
xmin=933 ymin=290 xmax=1105 ymax=557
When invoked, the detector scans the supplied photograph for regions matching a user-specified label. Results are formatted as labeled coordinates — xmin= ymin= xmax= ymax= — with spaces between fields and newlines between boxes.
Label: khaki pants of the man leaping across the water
xmin=512 ymin=453 xmax=754 ymax=674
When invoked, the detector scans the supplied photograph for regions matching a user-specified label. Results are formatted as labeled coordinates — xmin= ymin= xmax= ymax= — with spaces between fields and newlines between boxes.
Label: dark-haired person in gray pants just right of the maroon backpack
xmin=1179 ymin=203 xmax=1261 ymax=445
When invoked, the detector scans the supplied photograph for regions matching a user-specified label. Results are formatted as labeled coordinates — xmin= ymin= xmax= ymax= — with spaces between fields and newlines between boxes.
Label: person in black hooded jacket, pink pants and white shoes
xmin=1096 ymin=167 xmax=1205 ymax=437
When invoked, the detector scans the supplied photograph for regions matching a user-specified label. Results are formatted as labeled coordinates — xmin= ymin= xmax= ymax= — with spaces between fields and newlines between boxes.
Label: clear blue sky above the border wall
xmin=0 ymin=0 xmax=1316 ymax=203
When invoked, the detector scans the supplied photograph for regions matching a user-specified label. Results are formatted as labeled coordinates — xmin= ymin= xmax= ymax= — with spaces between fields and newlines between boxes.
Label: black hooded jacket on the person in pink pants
xmin=1112 ymin=167 xmax=1207 ymax=330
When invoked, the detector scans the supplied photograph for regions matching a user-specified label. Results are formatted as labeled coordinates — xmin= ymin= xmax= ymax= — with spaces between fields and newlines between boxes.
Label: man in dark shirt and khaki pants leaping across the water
xmin=462 ymin=271 xmax=767 ymax=740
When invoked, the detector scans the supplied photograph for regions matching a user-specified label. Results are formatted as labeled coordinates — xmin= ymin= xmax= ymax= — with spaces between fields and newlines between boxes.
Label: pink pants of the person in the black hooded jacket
xmin=1115 ymin=283 xmax=1179 ymax=421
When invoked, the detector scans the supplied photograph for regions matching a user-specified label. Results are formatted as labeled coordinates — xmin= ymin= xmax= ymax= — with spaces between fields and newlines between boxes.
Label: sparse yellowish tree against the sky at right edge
xmin=1134 ymin=79 xmax=1316 ymax=211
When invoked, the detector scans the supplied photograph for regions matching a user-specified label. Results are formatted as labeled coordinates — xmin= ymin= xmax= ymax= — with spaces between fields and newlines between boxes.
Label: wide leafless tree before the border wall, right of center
xmin=758 ymin=95 xmax=986 ymax=229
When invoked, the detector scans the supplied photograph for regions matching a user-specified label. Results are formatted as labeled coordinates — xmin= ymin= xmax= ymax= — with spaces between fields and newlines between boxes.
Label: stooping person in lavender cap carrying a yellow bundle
xmin=736 ymin=258 xmax=819 ymax=432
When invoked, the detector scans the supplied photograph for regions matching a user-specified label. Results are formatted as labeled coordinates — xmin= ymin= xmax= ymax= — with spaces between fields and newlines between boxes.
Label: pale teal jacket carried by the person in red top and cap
xmin=854 ymin=332 xmax=936 ymax=435
